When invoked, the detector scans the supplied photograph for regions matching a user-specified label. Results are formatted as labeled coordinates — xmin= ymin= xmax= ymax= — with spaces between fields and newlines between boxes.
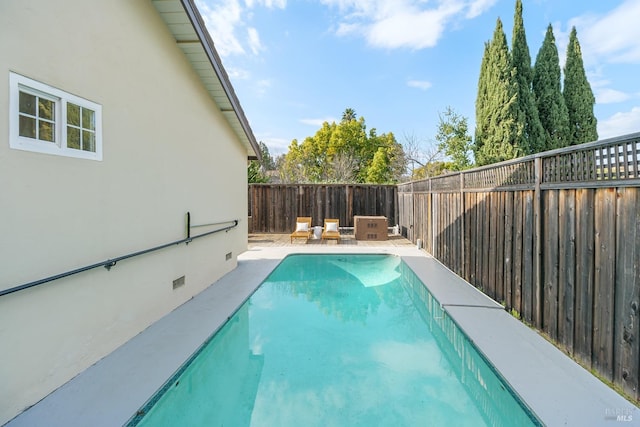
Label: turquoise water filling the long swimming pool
xmin=130 ymin=255 xmax=539 ymax=427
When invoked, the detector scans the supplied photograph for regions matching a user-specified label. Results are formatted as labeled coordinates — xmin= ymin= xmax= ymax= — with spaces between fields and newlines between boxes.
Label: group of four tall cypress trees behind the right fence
xmin=473 ymin=0 xmax=598 ymax=165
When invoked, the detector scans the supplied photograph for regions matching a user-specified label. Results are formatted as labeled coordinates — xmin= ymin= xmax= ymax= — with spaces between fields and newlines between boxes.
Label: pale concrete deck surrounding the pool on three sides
xmin=7 ymin=235 xmax=640 ymax=427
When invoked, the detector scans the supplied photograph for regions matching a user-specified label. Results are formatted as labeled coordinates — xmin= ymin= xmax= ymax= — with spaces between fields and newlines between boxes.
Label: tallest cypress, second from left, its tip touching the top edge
xmin=511 ymin=0 xmax=545 ymax=154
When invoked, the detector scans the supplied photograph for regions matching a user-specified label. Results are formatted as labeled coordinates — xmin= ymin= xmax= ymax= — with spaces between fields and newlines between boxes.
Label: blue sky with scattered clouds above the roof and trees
xmin=196 ymin=0 xmax=640 ymax=156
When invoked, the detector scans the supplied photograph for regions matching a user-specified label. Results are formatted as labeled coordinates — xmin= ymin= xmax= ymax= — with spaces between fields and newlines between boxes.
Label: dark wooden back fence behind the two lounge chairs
xmin=249 ymin=184 xmax=398 ymax=233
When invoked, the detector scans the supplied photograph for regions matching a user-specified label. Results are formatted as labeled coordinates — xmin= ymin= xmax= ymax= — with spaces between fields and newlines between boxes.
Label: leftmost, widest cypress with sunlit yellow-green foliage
xmin=474 ymin=18 xmax=524 ymax=166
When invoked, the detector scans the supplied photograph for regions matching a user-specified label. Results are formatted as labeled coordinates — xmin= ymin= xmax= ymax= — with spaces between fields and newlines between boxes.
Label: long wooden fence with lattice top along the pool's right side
xmin=398 ymin=133 xmax=640 ymax=402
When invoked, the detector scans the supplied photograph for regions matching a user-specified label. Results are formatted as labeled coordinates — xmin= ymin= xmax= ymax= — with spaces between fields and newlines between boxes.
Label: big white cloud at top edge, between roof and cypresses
xmin=320 ymin=0 xmax=497 ymax=49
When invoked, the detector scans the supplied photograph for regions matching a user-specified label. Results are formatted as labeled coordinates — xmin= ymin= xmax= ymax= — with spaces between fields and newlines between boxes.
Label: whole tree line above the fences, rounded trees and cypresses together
xmin=260 ymin=0 xmax=598 ymax=183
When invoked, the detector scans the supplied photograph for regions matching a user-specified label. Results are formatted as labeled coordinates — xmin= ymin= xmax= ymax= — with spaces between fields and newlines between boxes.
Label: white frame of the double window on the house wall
xmin=9 ymin=72 xmax=102 ymax=161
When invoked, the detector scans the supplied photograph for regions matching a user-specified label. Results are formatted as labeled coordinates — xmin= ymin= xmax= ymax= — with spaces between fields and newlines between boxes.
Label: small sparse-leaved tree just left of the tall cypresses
xmin=436 ymin=107 xmax=471 ymax=171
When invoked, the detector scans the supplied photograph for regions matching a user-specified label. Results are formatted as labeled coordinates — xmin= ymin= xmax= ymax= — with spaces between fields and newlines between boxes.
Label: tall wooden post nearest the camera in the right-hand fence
xmin=532 ymin=156 xmax=544 ymax=329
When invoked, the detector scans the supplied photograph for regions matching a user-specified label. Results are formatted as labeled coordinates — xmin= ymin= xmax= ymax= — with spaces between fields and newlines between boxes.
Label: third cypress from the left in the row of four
xmin=532 ymin=24 xmax=569 ymax=150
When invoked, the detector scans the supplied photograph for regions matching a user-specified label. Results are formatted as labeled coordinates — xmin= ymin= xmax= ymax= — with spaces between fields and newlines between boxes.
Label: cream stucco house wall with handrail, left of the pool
xmin=0 ymin=0 xmax=256 ymax=425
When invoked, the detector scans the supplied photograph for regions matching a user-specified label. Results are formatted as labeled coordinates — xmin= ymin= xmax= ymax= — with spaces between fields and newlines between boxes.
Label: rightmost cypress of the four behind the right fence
xmin=562 ymin=27 xmax=598 ymax=145
